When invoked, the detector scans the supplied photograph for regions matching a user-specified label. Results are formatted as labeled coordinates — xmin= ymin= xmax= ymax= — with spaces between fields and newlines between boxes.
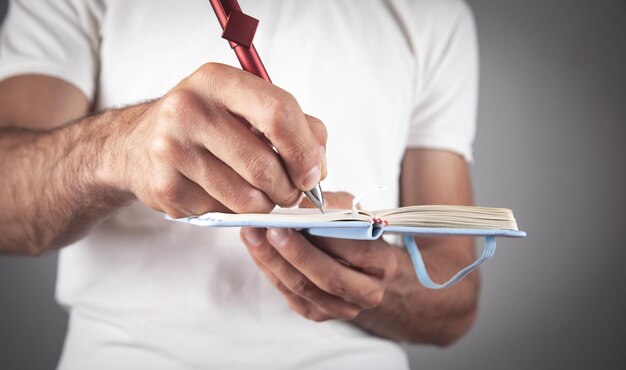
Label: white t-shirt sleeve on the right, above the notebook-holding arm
xmin=407 ymin=1 xmax=478 ymax=162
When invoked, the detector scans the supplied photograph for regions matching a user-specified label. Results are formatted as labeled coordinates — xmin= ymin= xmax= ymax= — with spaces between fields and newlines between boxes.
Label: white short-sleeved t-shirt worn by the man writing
xmin=0 ymin=0 xmax=478 ymax=370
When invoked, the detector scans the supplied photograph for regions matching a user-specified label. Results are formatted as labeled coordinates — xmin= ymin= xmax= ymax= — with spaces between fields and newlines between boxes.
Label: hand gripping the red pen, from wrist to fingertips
xmin=100 ymin=63 xmax=326 ymax=217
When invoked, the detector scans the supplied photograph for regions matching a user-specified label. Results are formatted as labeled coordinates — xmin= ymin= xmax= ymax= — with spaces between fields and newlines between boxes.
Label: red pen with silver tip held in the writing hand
xmin=209 ymin=0 xmax=324 ymax=213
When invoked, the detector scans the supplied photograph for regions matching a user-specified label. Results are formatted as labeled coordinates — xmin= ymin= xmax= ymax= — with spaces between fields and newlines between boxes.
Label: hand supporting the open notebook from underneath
xmin=241 ymin=193 xmax=399 ymax=321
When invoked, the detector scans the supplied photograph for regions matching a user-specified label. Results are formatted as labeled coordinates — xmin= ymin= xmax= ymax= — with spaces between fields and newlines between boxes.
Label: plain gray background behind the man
xmin=0 ymin=0 xmax=626 ymax=369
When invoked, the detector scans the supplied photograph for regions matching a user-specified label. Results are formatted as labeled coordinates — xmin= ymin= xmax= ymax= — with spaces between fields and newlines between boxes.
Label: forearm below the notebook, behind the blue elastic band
xmin=354 ymin=238 xmax=479 ymax=345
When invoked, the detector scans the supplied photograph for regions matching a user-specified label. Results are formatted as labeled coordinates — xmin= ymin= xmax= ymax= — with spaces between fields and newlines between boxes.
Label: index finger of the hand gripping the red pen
xmin=187 ymin=63 xmax=325 ymax=191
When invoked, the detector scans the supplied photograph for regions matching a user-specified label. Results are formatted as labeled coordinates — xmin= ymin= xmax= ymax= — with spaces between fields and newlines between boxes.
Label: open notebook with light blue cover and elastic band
xmin=169 ymin=205 xmax=526 ymax=289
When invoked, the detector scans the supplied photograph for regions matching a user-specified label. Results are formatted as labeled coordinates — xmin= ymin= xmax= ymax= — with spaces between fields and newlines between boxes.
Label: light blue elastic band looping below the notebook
xmin=404 ymin=235 xmax=496 ymax=289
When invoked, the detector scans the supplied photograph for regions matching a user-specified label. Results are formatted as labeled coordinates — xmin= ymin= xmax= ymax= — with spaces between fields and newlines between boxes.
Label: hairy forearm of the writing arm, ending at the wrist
xmin=0 ymin=107 xmax=141 ymax=255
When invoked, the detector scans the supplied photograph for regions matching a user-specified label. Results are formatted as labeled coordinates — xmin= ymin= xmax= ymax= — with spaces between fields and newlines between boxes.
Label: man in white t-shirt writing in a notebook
xmin=0 ymin=0 xmax=478 ymax=369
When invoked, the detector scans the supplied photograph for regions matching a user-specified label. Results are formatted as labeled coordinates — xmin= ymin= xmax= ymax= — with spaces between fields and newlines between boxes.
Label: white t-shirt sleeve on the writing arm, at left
xmin=0 ymin=0 xmax=100 ymax=101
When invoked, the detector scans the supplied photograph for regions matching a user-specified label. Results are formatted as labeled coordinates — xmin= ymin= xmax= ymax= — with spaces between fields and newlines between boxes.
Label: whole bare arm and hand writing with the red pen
xmin=0 ymin=64 xmax=326 ymax=255
